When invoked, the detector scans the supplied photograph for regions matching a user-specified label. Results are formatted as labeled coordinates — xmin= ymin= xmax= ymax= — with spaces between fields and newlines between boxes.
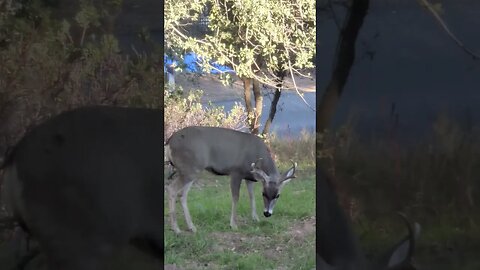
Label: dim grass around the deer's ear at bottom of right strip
xmin=354 ymin=215 xmax=480 ymax=270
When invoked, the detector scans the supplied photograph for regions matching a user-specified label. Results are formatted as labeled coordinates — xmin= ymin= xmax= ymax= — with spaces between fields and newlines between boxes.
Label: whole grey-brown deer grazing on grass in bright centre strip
xmin=165 ymin=126 xmax=297 ymax=234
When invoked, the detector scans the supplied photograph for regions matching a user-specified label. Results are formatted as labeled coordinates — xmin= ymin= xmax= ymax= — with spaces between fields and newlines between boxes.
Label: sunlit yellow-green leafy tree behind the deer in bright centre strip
xmin=165 ymin=0 xmax=316 ymax=134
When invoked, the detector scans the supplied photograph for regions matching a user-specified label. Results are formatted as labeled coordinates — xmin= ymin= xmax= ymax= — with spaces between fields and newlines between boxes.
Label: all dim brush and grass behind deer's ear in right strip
xmin=319 ymin=113 xmax=480 ymax=269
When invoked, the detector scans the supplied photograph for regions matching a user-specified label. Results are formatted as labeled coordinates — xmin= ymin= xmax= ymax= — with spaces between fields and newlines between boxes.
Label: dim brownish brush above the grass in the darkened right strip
xmin=318 ymin=114 xmax=480 ymax=227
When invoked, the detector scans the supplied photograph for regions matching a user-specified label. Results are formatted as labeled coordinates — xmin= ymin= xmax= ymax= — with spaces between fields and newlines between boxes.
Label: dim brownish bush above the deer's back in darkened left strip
xmin=0 ymin=1 xmax=163 ymax=155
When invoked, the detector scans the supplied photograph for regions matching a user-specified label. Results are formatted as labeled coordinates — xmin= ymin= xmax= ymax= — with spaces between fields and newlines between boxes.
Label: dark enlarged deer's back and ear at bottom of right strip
xmin=316 ymin=165 xmax=421 ymax=270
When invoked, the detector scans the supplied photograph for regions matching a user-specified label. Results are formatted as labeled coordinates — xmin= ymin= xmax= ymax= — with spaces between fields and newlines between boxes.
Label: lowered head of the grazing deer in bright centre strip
xmin=251 ymin=160 xmax=297 ymax=217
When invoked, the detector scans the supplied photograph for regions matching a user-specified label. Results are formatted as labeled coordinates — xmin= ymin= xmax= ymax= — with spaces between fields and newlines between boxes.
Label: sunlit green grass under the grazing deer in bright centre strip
xmin=165 ymin=165 xmax=315 ymax=269
